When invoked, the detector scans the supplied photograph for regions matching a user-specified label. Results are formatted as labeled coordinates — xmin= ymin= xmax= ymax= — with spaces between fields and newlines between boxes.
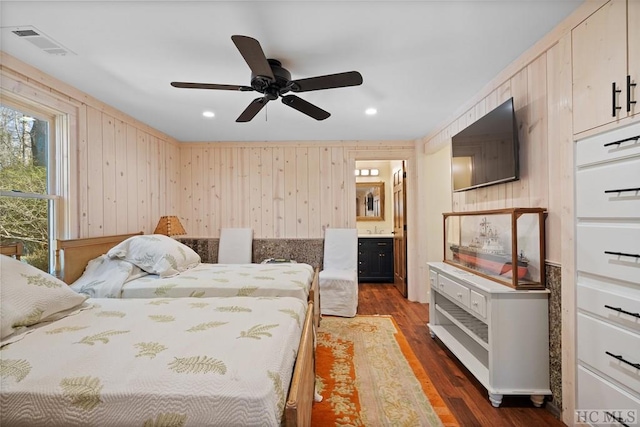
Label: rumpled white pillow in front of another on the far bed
xmin=69 ymin=255 xmax=149 ymax=298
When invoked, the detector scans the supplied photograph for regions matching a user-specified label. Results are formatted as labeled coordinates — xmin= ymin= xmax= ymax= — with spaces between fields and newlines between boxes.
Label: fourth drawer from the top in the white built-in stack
xmin=578 ymin=278 xmax=640 ymax=335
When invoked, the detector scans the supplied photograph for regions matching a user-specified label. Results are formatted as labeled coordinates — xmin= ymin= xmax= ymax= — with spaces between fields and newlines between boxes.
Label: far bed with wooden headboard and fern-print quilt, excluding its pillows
xmin=56 ymin=233 xmax=320 ymax=327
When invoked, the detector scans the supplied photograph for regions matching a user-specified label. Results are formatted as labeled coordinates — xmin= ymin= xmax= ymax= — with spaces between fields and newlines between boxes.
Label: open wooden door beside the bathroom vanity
xmin=393 ymin=161 xmax=407 ymax=298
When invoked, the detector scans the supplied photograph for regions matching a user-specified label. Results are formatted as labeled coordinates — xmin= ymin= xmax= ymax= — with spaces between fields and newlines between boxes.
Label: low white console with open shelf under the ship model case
xmin=429 ymin=262 xmax=551 ymax=407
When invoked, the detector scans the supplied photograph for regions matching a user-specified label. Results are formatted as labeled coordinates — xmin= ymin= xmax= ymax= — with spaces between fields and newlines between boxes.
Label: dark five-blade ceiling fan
xmin=171 ymin=35 xmax=362 ymax=122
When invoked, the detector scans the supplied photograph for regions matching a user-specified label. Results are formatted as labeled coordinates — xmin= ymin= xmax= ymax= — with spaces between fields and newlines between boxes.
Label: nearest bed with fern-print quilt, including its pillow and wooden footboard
xmin=0 ymin=255 xmax=315 ymax=426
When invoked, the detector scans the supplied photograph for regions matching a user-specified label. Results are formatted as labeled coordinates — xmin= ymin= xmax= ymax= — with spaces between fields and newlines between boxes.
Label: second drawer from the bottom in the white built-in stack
xmin=578 ymin=313 xmax=640 ymax=393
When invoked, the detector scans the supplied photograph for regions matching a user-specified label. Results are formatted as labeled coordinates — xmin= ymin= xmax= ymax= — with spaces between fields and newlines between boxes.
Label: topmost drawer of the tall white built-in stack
xmin=576 ymin=124 xmax=640 ymax=167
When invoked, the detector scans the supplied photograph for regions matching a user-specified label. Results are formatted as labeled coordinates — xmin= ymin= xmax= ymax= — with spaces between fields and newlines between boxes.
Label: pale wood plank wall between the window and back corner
xmin=78 ymin=106 xmax=180 ymax=237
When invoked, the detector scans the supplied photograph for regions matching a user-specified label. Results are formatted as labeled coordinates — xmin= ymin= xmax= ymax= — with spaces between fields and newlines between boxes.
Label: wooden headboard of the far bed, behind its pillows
xmin=56 ymin=231 xmax=143 ymax=284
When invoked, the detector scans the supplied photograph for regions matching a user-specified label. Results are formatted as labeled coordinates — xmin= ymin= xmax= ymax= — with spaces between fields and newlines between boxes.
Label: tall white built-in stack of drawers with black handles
xmin=576 ymin=118 xmax=640 ymax=426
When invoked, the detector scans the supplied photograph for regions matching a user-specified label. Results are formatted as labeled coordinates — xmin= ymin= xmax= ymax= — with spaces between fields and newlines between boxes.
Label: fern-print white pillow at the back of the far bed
xmin=107 ymin=234 xmax=200 ymax=277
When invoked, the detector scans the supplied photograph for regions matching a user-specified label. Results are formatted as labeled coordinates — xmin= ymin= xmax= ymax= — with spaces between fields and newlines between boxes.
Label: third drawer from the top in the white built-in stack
xmin=576 ymin=223 xmax=640 ymax=284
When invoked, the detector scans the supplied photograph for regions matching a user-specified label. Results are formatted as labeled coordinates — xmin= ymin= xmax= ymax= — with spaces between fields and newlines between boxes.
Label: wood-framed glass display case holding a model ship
xmin=443 ymin=208 xmax=546 ymax=289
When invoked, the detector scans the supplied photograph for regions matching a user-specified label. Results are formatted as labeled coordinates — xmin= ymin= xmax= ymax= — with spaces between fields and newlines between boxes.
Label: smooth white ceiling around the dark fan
xmin=0 ymin=0 xmax=582 ymax=141
